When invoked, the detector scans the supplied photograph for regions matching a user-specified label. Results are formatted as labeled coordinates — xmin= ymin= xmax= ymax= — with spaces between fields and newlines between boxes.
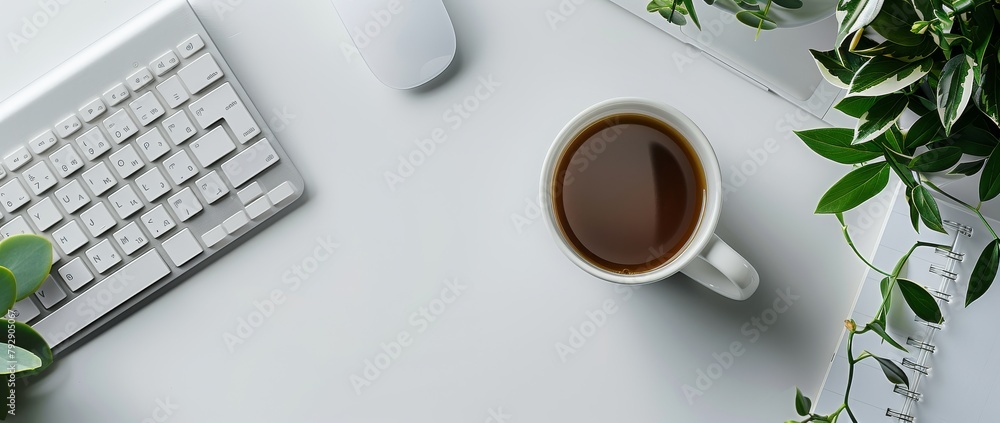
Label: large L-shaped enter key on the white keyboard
xmin=188 ymin=82 xmax=260 ymax=144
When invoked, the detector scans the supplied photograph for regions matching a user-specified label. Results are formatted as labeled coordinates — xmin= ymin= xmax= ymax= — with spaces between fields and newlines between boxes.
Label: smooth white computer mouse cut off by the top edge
xmin=332 ymin=0 xmax=457 ymax=90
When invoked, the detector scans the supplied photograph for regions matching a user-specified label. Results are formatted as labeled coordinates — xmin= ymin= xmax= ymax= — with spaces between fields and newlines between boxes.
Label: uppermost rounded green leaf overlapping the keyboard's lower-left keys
xmin=0 ymin=234 xmax=52 ymax=301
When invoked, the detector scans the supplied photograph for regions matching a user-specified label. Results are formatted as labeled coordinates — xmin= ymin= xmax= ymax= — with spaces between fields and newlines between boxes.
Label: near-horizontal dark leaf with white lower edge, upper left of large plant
xmin=848 ymin=56 xmax=934 ymax=97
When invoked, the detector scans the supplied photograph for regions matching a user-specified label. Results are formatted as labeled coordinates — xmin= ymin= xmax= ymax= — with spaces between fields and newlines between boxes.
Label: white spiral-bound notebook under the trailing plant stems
xmin=815 ymin=189 xmax=1000 ymax=423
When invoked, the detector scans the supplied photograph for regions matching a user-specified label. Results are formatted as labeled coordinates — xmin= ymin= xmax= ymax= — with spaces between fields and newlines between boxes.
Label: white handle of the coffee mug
xmin=681 ymin=234 xmax=760 ymax=301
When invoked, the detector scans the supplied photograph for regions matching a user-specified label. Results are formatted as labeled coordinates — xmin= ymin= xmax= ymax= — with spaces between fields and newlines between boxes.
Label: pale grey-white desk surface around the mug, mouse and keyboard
xmin=0 ymin=0 xmax=884 ymax=423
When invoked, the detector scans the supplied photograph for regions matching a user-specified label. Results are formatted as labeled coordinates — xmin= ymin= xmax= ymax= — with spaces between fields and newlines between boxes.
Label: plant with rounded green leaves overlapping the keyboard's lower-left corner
xmin=0 ymin=235 xmax=52 ymax=420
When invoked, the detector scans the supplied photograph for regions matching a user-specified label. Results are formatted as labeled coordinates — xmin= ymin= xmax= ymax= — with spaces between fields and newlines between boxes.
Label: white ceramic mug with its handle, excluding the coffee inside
xmin=540 ymin=98 xmax=760 ymax=300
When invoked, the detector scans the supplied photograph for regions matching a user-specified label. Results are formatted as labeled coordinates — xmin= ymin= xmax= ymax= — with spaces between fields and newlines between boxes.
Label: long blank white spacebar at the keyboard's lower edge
xmin=32 ymin=250 xmax=170 ymax=347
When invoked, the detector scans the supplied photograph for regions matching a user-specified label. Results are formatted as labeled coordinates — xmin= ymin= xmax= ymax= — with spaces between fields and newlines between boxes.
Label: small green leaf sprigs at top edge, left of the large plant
xmin=646 ymin=0 xmax=802 ymax=35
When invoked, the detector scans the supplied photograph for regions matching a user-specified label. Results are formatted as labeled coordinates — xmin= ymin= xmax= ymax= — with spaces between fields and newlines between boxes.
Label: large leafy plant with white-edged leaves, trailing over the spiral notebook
xmin=789 ymin=0 xmax=1000 ymax=423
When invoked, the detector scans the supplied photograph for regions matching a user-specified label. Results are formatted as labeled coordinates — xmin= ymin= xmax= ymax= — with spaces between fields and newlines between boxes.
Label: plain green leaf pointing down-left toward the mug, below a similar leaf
xmin=816 ymin=162 xmax=889 ymax=213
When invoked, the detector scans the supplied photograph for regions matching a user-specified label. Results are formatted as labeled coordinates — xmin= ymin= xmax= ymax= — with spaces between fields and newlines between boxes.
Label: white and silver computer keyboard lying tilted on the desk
xmin=0 ymin=0 xmax=304 ymax=354
